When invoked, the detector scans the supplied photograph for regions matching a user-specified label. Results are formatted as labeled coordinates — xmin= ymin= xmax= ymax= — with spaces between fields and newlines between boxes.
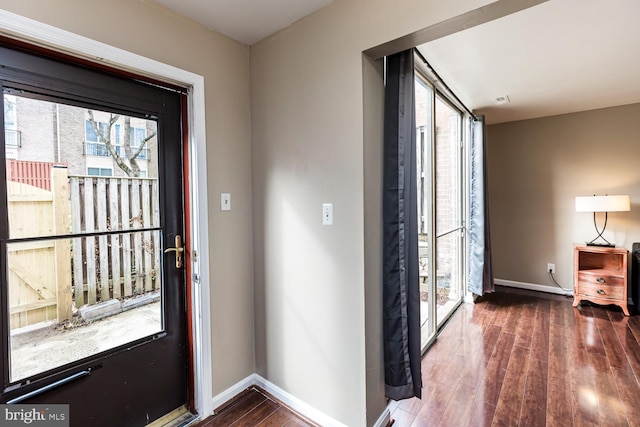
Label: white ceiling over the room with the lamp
xmin=419 ymin=0 xmax=640 ymax=123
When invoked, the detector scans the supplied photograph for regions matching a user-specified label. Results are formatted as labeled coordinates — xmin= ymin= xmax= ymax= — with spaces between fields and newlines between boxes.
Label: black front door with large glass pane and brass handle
xmin=0 ymin=42 xmax=188 ymax=426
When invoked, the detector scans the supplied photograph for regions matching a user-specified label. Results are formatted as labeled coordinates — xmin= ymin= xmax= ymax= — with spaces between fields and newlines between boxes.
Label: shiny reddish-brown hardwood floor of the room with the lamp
xmin=389 ymin=289 xmax=640 ymax=427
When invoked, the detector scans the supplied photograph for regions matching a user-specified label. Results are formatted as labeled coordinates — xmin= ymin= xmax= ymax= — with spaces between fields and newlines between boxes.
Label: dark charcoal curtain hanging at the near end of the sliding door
xmin=383 ymin=50 xmax=422 ymax=400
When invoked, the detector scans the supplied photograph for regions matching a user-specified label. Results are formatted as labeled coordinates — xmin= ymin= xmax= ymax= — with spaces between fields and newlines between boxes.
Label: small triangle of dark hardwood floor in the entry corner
xmin=196 ymin=387 xmax=316 ymax=427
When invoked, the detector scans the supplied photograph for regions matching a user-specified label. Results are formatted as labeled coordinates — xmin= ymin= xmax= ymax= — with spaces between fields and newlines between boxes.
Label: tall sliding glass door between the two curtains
xmin=415 ymin=73 xmax=464 ymax=349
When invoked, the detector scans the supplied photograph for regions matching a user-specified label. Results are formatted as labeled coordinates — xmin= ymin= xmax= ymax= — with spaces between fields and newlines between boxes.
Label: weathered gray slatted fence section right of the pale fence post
xmin=69 ymin=176 xmax=160 ymax=307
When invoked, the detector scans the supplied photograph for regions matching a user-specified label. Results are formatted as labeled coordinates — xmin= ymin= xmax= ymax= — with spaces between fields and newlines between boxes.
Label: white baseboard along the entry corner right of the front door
xmin=211 ymin=374 xmax=348 ymax=427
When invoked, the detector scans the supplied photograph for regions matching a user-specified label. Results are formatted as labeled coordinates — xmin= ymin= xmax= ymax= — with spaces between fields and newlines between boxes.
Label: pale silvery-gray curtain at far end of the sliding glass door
xmin=467 ymin=116 xmax=495 ymax=295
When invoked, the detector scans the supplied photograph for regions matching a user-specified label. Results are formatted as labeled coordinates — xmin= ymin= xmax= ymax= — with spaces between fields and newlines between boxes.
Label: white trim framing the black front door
xmin=0 ymin=9 xmax=213 ymax=417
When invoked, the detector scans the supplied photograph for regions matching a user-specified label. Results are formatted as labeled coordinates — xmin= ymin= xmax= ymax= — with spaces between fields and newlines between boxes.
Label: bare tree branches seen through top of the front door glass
xmin=88 ymin=110 xmax=156 ymax=177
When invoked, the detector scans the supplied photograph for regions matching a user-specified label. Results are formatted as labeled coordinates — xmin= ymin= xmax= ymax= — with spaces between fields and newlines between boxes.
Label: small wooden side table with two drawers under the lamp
xmin=573 ymin=245 xmax=629 ymax=316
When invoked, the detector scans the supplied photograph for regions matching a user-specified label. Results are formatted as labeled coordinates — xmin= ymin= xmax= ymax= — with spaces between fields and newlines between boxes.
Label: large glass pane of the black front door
xmin=4 ymin=95 xmax=163 ymax=382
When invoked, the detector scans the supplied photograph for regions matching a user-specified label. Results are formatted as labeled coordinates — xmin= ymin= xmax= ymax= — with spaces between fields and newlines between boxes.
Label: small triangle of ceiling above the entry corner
xmin=155 ymin=0 xmax=333 ymax=46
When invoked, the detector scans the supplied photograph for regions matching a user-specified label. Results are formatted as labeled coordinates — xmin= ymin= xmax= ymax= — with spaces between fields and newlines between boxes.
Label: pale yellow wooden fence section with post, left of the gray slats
xmin=7 ymin=167 xmax=72 ymax=329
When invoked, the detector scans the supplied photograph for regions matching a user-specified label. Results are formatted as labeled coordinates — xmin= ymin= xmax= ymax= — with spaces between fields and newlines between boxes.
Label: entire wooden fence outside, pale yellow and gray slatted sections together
xmin=7 ymin=162 xmax=160 ymax=329
